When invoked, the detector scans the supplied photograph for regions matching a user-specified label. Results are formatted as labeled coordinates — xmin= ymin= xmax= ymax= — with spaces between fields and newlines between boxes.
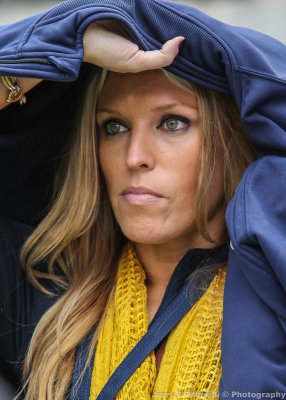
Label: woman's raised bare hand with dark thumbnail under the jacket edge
xmin=83 ymin=20 xmax=184 ymax=73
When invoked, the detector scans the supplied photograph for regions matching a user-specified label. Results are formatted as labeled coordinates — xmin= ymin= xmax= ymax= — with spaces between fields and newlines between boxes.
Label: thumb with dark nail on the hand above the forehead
xmin=126 ymin=36 xmax=185 ymax=72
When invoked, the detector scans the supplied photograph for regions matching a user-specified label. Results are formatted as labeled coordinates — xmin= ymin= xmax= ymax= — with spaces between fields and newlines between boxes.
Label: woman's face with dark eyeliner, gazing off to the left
xmin=97 ymin=70 xmax=225 ymax=248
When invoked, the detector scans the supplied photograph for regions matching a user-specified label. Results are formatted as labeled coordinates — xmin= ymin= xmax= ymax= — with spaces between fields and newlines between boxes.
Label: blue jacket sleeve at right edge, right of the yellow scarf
xmin=220 ymin=156 xmax=286 ymax=399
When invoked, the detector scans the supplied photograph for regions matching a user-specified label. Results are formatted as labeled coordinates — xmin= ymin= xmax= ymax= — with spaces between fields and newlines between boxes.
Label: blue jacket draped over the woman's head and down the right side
xmin=0 ymin=0 xmax=286 ymax=399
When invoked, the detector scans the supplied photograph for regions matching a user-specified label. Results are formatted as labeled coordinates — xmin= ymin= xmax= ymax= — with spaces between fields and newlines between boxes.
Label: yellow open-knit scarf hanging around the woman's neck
xmin=90 ymin=244 xmax=225 ymax=400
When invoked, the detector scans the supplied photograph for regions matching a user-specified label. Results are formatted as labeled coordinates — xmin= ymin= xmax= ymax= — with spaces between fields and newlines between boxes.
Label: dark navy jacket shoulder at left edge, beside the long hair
xmin=0 ymin=217 xmax=56 ymax=382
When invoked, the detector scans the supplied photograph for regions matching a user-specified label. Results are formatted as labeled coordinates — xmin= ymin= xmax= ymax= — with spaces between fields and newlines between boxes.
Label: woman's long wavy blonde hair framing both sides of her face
xmin=21 ymin=70 xmax=255 ymax=400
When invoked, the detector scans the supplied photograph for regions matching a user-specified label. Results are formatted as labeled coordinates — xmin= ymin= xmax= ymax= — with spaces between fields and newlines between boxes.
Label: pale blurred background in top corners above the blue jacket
xmin=0 ymin=0 xmax=286 ymax=43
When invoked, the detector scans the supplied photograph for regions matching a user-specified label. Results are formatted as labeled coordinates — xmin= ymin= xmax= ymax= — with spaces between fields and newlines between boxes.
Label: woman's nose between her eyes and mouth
xmin=126 ymin=126 xmax=155 ymax=171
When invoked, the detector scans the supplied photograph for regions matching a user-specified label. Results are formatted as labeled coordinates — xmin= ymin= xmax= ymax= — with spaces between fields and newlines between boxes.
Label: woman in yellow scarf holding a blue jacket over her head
xmin=1 ymin=1 xmax=285 ymax=399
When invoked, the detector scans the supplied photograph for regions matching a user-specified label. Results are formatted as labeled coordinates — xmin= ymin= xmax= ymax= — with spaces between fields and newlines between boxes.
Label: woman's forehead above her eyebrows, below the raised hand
xmin=99 ymin=70 xmax=197 ymax=108
